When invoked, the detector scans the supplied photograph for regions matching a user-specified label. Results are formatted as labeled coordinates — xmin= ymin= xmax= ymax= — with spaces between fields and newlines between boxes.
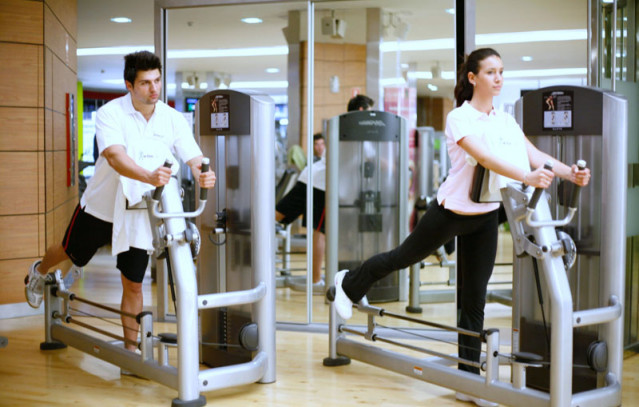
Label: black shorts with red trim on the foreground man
xmin=62 ymin=204 xmax=149 ymax=283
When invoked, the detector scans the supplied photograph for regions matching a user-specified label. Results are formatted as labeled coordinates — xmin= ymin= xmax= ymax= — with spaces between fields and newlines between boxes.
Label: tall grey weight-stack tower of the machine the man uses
xmin=196 ymin=90 xmax=275 ymax=380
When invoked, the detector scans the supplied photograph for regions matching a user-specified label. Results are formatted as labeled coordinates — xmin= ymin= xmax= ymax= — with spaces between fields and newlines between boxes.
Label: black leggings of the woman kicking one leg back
xmin=342 ymin=205 xmax=498 ymax=373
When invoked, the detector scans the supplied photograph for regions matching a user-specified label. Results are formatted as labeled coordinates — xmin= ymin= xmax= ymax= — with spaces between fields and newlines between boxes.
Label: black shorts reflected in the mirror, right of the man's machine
xmin=275 ymin=182 xmax=326 ymax=233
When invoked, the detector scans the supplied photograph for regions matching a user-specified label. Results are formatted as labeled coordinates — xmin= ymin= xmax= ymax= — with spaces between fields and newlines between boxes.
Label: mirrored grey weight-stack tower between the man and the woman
xmin=325 ymin=111 xmax=408 ymax=302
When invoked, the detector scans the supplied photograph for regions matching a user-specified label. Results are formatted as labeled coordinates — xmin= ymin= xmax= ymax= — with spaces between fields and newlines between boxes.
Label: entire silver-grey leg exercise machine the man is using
xmin=40 ymin=91 xmax=275 ymax=407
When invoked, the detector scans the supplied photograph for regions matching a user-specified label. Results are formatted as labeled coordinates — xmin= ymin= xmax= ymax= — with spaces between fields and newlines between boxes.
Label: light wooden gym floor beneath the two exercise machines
xmin=0 ymin=237 xmax=639 ymax=407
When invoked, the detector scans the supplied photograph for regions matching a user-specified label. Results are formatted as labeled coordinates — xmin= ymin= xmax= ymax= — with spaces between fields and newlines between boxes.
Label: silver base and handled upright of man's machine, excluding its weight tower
xmin=40 ymin=163 xmax=216 ymax=406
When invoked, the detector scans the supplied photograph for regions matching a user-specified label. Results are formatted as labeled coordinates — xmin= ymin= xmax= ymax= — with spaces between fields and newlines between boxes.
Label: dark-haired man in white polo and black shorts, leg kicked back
xmin=25 ymin=51 xmax=215 ymax=356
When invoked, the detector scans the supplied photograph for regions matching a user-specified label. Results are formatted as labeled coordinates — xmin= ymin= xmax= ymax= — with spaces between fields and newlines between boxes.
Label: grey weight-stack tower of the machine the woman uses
xmin=513 ymin=86 xmax=628 ymax=398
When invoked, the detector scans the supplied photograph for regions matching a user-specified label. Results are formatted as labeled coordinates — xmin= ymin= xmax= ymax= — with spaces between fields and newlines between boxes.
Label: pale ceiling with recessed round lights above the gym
xmin=78 ymin=0 xmax=587 ymax=97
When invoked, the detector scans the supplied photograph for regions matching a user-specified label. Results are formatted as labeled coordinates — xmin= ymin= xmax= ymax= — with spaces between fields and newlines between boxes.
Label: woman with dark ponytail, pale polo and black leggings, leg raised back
xmin=335 ymin=48 xmax=590 ymax=406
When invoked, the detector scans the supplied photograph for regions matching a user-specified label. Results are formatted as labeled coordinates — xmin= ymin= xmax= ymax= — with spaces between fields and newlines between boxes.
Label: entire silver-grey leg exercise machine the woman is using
xmin=324 ymin=87 xmax=628 ymax=407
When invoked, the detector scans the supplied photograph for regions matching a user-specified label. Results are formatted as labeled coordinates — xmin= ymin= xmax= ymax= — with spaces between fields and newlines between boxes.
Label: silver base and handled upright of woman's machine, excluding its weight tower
xmin=324 ymin=167 xmax=623 ymax=407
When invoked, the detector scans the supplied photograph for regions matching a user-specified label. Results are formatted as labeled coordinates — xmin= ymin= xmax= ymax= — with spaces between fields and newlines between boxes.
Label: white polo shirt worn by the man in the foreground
xmin=80 ymin=93 xmax=202 ymax=222
